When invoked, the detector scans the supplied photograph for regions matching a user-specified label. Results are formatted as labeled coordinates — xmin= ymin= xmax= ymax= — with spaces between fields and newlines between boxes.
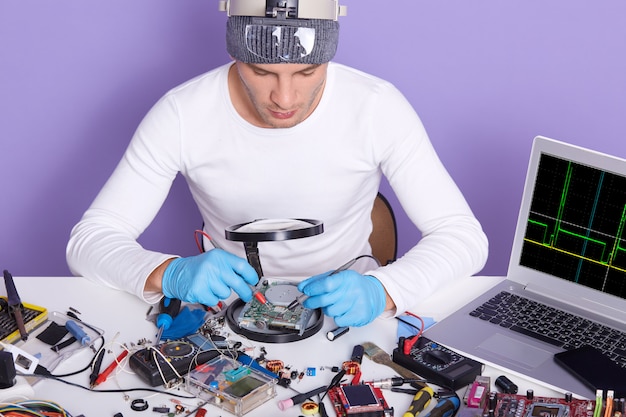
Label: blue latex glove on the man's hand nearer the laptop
xmin=298 ymin=270 xmax=387 ymax=327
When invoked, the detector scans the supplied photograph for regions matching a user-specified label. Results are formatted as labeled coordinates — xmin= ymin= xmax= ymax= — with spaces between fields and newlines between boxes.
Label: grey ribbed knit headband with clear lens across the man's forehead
xmin=226 ymin=16 xmax=339 ymax=64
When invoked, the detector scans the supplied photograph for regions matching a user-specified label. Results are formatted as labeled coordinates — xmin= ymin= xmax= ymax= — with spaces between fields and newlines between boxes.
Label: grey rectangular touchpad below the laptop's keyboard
xmin=476 ymin=333 xmax=553 ymax=369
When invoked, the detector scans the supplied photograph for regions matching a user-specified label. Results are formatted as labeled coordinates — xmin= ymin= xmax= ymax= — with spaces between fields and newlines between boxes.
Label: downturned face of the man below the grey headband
xmin=230 ymin=61 xmax=328 ymax=128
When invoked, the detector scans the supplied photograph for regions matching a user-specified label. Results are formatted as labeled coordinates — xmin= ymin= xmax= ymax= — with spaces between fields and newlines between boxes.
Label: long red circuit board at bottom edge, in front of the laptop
xmin=480 ymin=392 xmax=596 ymax=417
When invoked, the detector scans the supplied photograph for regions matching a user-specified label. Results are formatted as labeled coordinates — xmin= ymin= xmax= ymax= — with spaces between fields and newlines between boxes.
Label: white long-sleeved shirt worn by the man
xmin=67 ymin=63 xmax=487 ymax=314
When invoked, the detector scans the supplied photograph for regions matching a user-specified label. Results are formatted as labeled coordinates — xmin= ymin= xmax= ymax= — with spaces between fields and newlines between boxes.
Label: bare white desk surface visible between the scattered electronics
xmin=6 ymin=277 xmax=562 ymax=417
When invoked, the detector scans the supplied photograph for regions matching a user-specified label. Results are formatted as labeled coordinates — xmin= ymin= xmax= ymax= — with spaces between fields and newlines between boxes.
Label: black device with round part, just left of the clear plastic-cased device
xmin=128 ymin=333 xmax=227 ymax=387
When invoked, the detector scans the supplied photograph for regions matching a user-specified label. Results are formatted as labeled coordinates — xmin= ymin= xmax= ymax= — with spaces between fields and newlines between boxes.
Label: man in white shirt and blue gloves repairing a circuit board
xmin=67 ymin=0 xmax=487 ymax=326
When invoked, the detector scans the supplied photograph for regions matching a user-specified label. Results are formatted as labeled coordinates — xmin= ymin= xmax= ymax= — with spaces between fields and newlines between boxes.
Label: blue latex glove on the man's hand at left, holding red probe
xmin=161 ymin=249 xmax=259 ymax=306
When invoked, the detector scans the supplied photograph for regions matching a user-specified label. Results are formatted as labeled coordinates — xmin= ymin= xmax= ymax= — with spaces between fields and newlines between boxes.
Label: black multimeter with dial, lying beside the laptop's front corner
xmin=392 ymin=336 xmax=483 ymax=390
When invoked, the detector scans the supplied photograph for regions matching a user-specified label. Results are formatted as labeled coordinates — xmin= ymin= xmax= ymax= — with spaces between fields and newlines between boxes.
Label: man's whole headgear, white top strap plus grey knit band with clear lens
xmin=220 ymin=0 xmax=347 ymax=64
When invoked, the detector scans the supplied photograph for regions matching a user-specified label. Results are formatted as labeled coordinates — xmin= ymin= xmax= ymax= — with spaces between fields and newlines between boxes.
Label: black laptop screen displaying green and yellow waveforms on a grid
xmin=510 ymin=138 xmax=626 ymax=299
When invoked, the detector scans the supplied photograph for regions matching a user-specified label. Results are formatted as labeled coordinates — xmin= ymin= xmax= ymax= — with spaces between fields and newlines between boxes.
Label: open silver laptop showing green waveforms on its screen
xmin=424 ymin=136 xmax=626 ymax=399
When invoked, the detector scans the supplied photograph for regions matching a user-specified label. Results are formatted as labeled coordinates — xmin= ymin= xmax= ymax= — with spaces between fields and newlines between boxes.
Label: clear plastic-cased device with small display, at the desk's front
xmin=186 ymin=355 xmax=277 ymax=417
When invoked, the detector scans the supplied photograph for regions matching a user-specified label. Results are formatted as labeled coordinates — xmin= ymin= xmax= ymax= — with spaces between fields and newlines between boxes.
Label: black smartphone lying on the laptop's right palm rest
xmin=554 ymin=345 xmax=626 ymax=398
